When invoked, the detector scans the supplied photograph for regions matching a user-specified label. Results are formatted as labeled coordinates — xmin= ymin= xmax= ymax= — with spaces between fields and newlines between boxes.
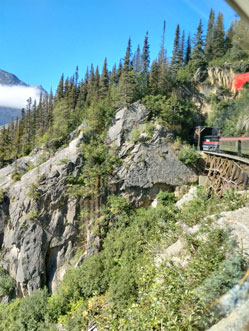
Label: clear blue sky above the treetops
xmin=0 ymin=0 xmax=236 ymax=90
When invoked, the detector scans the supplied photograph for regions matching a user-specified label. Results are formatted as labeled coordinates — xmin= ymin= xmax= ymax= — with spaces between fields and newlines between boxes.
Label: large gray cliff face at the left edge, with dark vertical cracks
xmin=0 ymin=130 xmax=82 ymax=296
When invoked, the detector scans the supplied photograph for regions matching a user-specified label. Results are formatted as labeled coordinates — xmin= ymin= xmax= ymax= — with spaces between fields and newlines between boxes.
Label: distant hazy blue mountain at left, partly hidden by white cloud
xmin=0 ymin=69 xmax=47 ymax=126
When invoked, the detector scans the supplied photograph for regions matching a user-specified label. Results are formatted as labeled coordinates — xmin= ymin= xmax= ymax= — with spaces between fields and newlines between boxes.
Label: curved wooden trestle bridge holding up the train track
xmin=204 ymin=152 xmax=249 ymax=194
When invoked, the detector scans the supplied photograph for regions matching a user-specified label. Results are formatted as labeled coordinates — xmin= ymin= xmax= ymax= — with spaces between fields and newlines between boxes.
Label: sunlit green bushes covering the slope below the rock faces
xmin=0 ymin=188 xmax=245 ymax=330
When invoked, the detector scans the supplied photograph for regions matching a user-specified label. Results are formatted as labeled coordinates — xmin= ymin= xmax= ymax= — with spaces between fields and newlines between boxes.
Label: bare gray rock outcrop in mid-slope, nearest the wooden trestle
xmin=108 ymin=102 xmax=197 ymax=205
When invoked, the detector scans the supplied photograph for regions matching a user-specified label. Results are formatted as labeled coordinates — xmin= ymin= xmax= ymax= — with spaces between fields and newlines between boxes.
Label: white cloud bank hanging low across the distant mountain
xmin=0 ymin=84 xmax=41 ymax=109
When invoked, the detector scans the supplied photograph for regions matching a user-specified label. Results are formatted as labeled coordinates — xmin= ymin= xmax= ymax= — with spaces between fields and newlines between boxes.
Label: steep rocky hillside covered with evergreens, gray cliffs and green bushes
xmin=0 ymin=10 xmax=249 ymax=331
